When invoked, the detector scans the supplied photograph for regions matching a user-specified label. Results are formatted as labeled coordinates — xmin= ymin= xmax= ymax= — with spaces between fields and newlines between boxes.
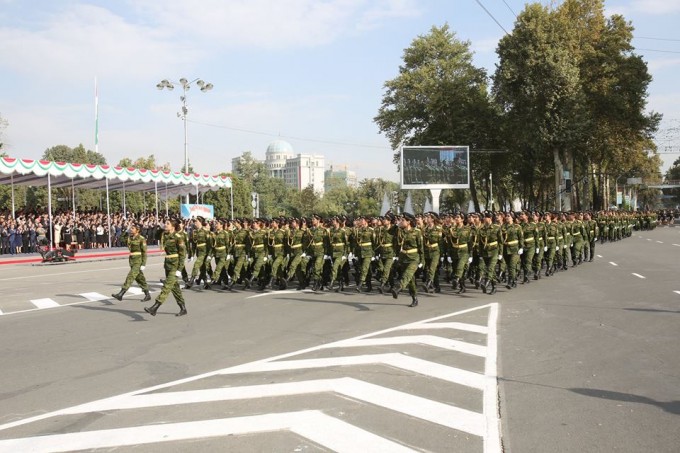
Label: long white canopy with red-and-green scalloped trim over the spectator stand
xmin=0 ymin=157 xmax=233 ymax=246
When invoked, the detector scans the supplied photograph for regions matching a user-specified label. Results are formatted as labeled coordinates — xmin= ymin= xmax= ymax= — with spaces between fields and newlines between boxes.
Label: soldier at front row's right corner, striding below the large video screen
xmin=392 ymin=213 xmax=423 ymax=307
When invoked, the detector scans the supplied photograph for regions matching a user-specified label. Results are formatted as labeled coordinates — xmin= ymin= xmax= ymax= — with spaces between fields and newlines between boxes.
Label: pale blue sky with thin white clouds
xmin=0 ymin=0 xmax=680 ymax=181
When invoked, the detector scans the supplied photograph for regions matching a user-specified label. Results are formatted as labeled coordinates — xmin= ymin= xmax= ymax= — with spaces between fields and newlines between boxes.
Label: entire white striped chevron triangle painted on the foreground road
xmin=0 ymin=303 xmax=502 ymax=453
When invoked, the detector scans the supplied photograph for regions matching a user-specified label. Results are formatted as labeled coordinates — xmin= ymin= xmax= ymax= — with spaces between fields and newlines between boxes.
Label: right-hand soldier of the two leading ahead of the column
xmin=144 ymin=220 xmax=187 ymax=316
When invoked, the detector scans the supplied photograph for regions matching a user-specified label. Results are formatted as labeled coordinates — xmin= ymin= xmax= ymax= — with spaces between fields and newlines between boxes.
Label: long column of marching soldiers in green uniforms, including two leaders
xmin=113 ymin=211 xmax=644 ymax=315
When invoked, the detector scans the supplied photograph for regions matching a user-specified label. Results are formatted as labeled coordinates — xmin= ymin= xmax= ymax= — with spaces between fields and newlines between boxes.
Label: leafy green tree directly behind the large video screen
xmin=374 ymin=25 xmax=498 ymax=213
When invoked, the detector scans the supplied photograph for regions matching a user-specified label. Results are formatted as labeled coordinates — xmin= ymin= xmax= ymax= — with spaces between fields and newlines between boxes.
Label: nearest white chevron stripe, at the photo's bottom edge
xmin=0 ymin=411 xmax=413 ymax=453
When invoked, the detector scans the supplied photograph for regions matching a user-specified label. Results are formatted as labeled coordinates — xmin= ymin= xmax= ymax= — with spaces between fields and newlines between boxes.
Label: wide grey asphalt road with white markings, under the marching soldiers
xmin=0 ymin=228 xmax=680 ymax=452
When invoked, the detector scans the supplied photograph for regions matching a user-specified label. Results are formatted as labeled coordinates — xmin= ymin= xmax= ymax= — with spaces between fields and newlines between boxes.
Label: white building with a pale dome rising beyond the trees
xmin=231 ymin=140 xmax=326 ymax=195
